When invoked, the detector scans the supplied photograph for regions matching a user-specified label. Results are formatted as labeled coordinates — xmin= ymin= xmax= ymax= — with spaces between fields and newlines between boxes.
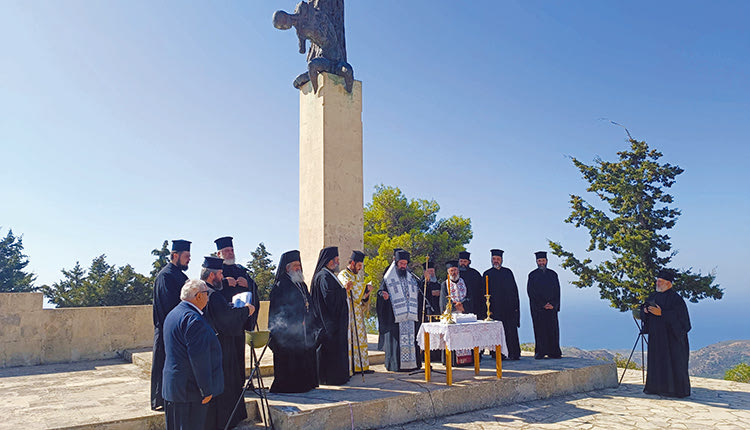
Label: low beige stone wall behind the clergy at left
xmin=0 ymin=293 xmax=268 ymax=367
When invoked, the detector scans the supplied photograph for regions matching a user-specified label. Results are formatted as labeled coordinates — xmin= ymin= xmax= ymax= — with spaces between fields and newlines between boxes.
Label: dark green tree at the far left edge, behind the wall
xmin=0 ymin=229 xmax=37 ymax=293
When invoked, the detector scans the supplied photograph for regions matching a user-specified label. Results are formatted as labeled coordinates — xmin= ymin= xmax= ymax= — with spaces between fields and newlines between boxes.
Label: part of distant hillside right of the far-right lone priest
xmin=690 ymin=340 xmax=750 ymax=379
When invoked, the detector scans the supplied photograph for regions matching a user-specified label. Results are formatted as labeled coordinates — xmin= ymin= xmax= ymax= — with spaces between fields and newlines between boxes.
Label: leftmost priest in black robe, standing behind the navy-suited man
xmin=151 ymin=239 xmax=190 ymax=411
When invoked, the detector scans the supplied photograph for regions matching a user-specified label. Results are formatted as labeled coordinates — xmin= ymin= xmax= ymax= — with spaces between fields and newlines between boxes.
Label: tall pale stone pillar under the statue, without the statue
xmin=299 ymin=73 xmax=364 ymax=285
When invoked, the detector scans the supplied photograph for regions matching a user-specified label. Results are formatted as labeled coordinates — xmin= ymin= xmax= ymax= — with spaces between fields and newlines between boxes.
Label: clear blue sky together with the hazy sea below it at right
xmin=0 ymin=0 xmax=750 ymax=348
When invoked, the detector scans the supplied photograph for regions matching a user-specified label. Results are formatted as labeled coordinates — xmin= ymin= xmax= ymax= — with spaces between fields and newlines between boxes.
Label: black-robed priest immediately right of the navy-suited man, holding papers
xmin=201 ymin=257 xmax=255 ymax=430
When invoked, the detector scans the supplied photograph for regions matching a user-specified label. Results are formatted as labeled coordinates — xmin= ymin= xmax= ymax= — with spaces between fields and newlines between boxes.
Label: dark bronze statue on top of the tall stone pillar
xmin=273 ymin=0 xmax=354 ymax=93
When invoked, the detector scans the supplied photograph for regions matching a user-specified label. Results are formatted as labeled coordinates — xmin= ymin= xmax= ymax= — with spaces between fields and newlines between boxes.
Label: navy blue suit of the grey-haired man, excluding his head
xmin=162 ymin=301 xmax=224 ymax=430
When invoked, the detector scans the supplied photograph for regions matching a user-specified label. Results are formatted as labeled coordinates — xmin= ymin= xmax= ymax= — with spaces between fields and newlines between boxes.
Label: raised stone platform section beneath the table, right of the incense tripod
xmin=268 ymin=355 xmax=617 ymax=430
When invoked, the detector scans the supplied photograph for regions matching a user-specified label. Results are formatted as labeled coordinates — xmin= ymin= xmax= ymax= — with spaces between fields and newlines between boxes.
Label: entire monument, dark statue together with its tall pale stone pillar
xmin=273 ymin=0 xmax=364 ymax=285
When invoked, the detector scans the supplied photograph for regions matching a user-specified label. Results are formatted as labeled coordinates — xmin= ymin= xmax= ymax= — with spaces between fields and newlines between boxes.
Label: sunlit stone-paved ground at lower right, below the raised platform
xmin=389 ymin=369 xmax=750 ymax=430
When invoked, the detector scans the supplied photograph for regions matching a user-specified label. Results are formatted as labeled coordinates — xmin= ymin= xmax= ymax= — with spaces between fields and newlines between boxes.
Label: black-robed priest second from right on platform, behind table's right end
xmin=483 ymin=249 xmax=521 ymax=360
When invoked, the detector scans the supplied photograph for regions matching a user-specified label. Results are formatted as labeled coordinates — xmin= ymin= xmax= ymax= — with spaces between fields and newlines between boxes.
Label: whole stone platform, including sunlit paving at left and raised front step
xmin=0 ymin=336 xmax=616 ymax=430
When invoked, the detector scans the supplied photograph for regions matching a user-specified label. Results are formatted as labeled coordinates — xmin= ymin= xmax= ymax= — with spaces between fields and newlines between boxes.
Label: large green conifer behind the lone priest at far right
xmin=549 ymin=138 xmax=723 ymax=312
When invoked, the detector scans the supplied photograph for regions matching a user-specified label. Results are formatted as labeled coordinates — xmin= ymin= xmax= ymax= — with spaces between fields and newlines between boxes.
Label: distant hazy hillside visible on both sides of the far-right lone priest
xmin=562 ymin=340 xmax=750 ymax=379
